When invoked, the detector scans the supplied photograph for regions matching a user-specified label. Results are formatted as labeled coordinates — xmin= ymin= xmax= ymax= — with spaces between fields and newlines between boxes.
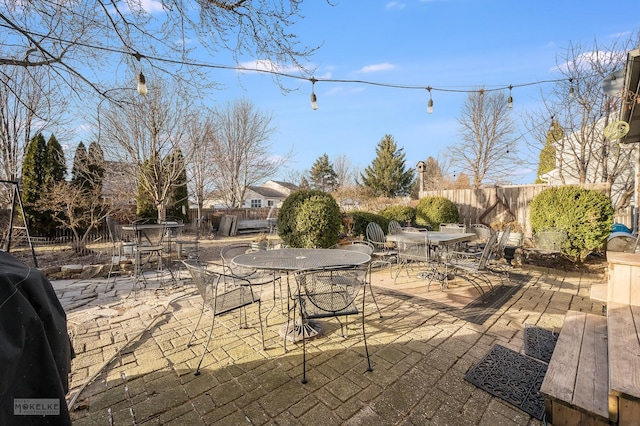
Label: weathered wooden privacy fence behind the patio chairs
xmin=420 ymin=184 xmax=632 ymax=236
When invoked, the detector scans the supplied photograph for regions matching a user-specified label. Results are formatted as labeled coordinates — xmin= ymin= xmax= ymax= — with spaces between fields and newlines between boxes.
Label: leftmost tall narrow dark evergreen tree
xmin=21 ymin=133 xmax=47 ymax=235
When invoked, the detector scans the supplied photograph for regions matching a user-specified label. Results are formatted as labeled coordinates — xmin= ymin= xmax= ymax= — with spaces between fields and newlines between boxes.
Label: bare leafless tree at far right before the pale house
xmin=527 ymin=38 xmax=637 ymax=207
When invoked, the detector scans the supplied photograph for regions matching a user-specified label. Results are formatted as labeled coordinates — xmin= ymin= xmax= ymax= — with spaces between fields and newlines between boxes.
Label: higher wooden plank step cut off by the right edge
xmin=607 ymin=302 xmax=640 ymax=425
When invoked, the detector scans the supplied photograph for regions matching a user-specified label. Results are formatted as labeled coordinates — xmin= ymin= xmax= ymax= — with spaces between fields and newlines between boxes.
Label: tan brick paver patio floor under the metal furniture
xmin=53 ymin=262 xmax=605 ymax=425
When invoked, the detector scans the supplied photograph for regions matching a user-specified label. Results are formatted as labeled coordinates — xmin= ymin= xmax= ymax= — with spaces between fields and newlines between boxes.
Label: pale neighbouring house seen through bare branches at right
xmin=540 ymin=118 xmax=635 ymax=210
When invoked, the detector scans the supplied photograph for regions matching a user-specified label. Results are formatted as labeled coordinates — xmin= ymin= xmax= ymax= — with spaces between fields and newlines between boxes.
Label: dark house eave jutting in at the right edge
xmin=620 ymin=49 xmax=640 ymax=143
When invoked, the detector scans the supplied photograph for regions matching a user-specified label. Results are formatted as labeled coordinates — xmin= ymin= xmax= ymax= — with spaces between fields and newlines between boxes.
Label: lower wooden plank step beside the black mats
xmin=540 ymin=311 xmax=610 ymax=425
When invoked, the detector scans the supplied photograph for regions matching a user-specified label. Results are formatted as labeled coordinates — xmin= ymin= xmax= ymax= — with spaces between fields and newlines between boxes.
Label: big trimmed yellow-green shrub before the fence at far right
xmin=531 ymin=186 xmax=614 ymax=261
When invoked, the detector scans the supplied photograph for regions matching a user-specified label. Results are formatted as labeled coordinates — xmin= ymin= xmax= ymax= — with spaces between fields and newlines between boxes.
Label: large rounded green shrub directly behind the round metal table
xmin=276 ymin=190 xmax=342 ymax=248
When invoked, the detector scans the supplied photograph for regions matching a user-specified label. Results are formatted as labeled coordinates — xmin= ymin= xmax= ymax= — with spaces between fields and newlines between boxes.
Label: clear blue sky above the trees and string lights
xmin=195 ymin=0 xmax=640 ymax=183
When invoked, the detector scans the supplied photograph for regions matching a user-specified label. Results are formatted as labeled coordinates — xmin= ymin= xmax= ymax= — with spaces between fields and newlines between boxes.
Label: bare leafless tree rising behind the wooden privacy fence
xmin=448 ymin=89 xmax=519 ymax=188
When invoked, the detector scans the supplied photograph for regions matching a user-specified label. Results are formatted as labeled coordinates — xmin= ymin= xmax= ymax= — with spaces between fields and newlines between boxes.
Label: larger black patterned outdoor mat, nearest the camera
xmin=464 ymin=344 xmax=547 ymax=420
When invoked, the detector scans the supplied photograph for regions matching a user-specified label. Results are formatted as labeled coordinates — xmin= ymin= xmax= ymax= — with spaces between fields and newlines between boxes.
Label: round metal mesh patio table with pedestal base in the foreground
xmin=231 ymin=248 xmax=371 ymax=344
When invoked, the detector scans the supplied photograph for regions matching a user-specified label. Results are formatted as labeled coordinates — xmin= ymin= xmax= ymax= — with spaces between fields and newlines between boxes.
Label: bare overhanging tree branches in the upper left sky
xmin=0 ymin=0 xmax=316 ymax=102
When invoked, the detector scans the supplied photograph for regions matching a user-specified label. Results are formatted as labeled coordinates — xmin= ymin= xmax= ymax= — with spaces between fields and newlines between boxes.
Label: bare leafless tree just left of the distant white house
xmin=210 ymin=99 xmax=291 ymax=207
